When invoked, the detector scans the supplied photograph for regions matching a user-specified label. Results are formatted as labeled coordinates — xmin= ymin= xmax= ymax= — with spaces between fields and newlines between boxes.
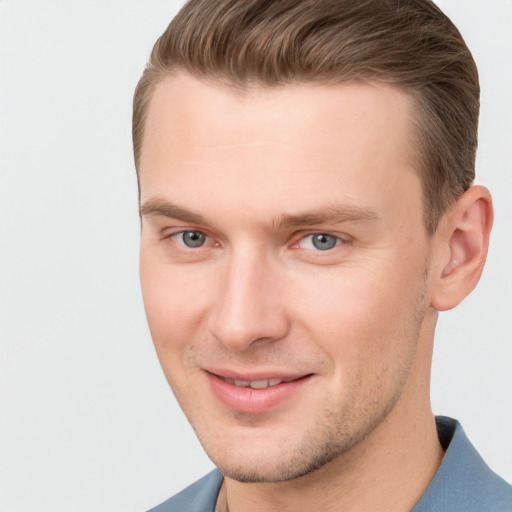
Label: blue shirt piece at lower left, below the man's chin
xmin=148 ymin=469 xmax=223 ymax=512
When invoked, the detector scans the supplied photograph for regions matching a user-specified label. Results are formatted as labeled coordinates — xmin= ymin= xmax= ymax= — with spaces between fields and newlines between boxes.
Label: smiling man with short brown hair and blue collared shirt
xmin=133 ymin=0 xmax=512 ymax=512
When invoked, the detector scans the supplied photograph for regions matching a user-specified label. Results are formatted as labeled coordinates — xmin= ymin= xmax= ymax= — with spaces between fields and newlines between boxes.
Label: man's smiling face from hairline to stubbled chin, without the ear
xmin=140 ymin=76 xmax=435 ymax=481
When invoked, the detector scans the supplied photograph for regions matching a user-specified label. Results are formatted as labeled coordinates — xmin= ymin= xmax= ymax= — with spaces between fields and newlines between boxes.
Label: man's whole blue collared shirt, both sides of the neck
xmin=148 ymin=416 xmax=512 ymax=512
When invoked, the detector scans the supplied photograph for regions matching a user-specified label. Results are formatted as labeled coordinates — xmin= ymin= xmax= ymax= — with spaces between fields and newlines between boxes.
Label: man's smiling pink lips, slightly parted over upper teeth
xmin=205 ymin=371 xmax=312 ymax=414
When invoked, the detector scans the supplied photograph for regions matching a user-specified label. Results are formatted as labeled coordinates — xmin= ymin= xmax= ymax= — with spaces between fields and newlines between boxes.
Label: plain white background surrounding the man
xmin=0 ymin=0 xmax=512 ymax=512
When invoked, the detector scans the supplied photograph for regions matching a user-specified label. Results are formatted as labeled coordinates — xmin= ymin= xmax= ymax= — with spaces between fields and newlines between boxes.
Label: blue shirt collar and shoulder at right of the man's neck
xmin=413 ymin=417 xmax=512 ymax=512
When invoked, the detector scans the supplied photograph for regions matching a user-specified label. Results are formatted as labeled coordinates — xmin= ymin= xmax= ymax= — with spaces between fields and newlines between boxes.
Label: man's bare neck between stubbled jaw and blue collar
xmin=219 ymin=308 xmax=443 ymax=512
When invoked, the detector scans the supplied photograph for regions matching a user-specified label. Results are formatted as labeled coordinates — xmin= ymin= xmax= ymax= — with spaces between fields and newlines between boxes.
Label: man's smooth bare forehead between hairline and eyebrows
xmin=139 ymin=75 xmax=420 ymax=224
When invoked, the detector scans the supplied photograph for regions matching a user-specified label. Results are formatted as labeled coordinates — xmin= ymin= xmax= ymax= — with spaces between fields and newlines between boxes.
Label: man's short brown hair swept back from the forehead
xmin=133 ymin=0 xmax=480 ymax=234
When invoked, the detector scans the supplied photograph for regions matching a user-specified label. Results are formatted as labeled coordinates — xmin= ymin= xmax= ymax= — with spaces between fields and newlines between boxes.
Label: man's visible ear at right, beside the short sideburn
xmin=431 ymin=185 xmax=494 ymax=311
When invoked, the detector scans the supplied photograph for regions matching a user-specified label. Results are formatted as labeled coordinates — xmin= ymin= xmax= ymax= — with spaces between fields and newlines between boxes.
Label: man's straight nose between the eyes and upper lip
xmin=211 ymin=251 xmax=289 ymax=351
